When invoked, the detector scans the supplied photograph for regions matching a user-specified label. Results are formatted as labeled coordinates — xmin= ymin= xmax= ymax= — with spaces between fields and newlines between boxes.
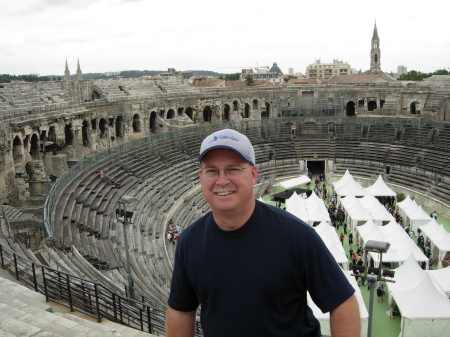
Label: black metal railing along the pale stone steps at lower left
xmin=0 ymin=244 xmax=169 ymax=335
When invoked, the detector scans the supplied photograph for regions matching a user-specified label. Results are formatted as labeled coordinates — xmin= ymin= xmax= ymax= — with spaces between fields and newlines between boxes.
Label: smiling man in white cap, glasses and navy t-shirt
xmin=167 ymin=129 xmax=360 ymax=337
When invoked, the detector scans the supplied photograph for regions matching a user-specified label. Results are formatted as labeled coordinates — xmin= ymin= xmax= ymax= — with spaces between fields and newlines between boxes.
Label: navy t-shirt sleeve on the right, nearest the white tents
xmin=304 ymin=230 xmax=355 ymax=313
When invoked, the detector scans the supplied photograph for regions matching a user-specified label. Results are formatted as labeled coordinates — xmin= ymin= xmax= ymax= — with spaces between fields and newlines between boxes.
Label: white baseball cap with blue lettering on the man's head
xmin=197 ymin=129 xmax=255 ymax=165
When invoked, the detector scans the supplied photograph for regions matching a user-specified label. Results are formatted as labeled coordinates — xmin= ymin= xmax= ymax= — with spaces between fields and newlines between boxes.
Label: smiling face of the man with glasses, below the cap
xmin=200 ymin=149 xmax=258 ymax=215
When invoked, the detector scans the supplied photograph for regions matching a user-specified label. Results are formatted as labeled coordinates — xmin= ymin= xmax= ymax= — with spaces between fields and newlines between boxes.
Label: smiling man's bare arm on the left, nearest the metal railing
xmin=166 ymin=307 xmax=196 ymax=337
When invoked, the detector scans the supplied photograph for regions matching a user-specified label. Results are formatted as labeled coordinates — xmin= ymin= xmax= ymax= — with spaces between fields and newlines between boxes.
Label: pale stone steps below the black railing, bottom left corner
xmin=0 ymin=271 xmax=154 ymax=337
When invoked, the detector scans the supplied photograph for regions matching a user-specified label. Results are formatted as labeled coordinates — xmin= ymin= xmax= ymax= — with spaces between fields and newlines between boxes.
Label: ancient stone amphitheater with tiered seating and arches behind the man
xmin=0 ymin=76 xmax=450 ymax=336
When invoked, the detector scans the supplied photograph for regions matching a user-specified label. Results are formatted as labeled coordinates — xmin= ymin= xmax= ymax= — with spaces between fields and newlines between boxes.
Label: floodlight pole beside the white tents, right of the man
xmin=352 ymin=240 xmax=395 ymax=337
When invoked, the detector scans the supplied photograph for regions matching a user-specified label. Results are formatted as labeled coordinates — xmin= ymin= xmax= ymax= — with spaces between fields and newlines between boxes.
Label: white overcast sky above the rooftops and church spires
xmin=0 ymin=0 xmax=450 ymax=75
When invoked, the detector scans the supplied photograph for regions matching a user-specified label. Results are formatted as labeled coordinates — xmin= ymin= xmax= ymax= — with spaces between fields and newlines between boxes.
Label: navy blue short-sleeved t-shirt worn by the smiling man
xmin=168 ymin=201 xmax=355 ymax=337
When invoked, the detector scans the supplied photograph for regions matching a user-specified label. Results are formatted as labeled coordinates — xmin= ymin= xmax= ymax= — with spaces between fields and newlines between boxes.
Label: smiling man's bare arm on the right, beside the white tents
xmin=330 ymin=295 xmax=361 ymax=337
